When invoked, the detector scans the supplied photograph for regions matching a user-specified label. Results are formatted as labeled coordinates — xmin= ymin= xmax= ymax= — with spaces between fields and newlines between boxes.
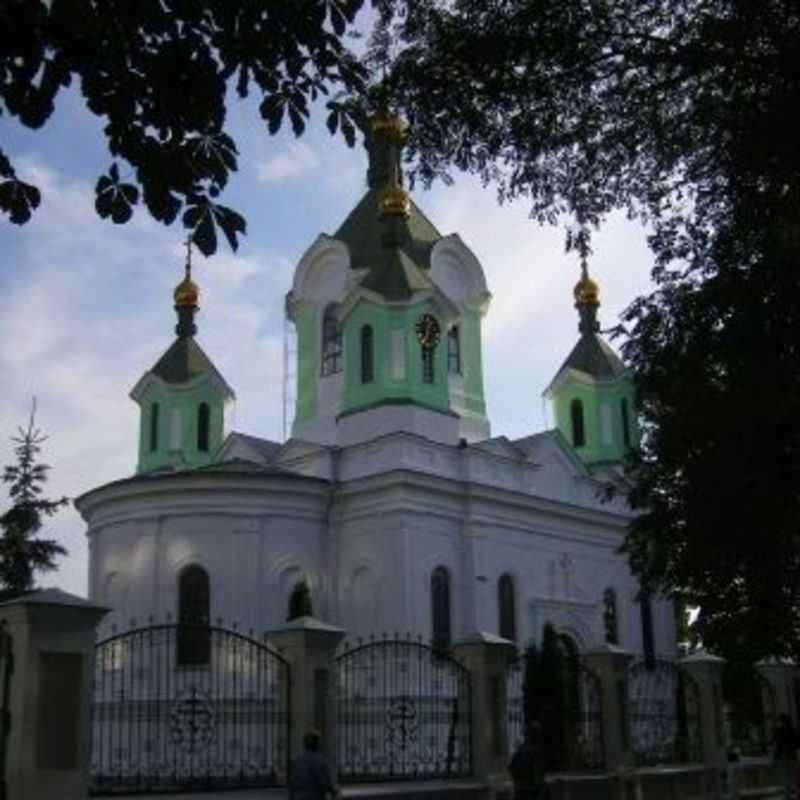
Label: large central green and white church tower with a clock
xmin=287 ymin=111 xmax=490 ymax=445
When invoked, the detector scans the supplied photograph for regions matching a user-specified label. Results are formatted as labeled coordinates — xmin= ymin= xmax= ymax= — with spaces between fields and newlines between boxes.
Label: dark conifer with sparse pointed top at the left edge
xmin=0 ymin=400 xmax=68 ymax=596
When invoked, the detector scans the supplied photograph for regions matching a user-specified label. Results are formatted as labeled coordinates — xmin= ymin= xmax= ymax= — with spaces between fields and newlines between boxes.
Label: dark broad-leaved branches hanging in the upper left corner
xmin=0 ymin=0 xmax=365 ymax=255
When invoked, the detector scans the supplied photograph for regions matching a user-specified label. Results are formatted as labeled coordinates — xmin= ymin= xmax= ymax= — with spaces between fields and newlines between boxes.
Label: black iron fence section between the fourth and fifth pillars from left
xmin=628 ymin=660 xmax=703 ymax=765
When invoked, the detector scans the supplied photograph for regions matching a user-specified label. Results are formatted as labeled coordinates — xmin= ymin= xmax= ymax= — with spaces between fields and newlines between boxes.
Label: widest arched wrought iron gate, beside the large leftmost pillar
xmin=90 ymin=625 xmax=289 ymax=794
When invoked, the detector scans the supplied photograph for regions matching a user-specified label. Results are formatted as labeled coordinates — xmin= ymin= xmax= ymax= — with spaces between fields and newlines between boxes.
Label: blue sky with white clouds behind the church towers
xmin=0 ymin=72 xmax=652 ymax=596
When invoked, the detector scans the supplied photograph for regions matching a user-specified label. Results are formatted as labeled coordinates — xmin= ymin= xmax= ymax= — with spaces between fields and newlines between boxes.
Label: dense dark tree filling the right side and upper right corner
xmin=372 ymin=0 xmax=800 ymax=659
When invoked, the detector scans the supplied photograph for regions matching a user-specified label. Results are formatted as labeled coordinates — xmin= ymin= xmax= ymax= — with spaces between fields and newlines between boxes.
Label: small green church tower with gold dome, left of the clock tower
xmin=130 ymin=250 xmax=235 ymax=473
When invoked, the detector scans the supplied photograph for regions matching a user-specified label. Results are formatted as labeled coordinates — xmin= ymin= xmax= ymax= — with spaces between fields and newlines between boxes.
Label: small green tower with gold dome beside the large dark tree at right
xmin=544 ymin=262 xmax=639 ymax=466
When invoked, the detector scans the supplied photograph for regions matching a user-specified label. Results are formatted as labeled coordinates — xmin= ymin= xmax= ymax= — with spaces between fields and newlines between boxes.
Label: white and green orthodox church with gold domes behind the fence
xmin=76 ymin=112 xmax=675 ymax=657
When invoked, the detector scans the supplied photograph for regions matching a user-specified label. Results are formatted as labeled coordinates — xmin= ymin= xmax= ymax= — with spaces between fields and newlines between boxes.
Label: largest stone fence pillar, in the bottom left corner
xmin=0 ymin=589 xmax=108 ymax=800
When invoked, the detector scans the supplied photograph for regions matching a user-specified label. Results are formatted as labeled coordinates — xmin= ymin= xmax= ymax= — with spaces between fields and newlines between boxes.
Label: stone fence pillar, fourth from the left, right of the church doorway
xmin=583 ymin=644 xmax=633 ymax=772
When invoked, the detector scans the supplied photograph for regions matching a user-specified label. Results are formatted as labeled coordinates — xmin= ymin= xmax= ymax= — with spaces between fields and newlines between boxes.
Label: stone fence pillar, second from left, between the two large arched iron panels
xmin=267 ymin=617 xmax=345 ymax=774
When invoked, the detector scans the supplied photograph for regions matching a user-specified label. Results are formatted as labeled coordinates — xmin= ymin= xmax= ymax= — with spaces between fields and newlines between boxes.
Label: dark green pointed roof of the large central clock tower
xmin=334 ymin=188 xmax=442 ymax=300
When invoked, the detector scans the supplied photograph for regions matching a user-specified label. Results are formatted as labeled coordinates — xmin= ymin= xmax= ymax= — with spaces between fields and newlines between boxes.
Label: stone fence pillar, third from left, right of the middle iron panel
xmin=453 ymin=631 xmax=516 ymax=784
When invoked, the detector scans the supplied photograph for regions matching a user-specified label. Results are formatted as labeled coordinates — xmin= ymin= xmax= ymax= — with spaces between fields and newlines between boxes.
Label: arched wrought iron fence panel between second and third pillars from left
xmin=335 ymin=638 xmax=472 ymax=781
